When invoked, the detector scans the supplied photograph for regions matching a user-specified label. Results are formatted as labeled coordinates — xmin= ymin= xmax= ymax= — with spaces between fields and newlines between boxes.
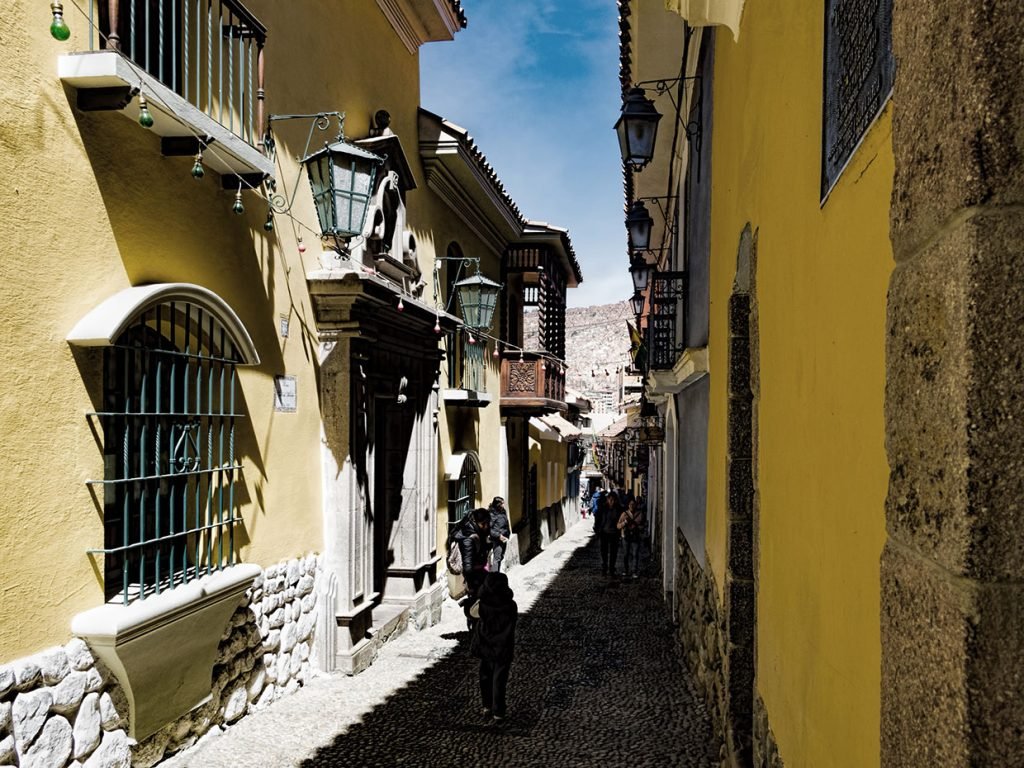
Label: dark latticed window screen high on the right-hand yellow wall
xmin=821 ymin=0 xmax=894 ymax=200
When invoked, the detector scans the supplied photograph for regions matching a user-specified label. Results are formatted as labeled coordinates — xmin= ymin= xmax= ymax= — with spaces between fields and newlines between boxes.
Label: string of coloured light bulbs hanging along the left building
xmin=50 ymin=0 xmax=567 ymax=373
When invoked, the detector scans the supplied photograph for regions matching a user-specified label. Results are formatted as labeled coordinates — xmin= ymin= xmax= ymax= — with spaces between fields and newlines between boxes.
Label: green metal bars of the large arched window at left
xmin=88 ymin=302 xmax=245 ymax=604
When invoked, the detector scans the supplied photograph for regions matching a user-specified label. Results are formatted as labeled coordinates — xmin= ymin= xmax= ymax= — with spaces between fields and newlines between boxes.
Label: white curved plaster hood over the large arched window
xmin=68 ymin=283 xmax=259 ymax=366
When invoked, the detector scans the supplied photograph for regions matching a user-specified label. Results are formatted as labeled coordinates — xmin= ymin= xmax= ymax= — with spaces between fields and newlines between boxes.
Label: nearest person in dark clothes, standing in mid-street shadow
xmin=469 ymin=573 xmax=519 ymax=722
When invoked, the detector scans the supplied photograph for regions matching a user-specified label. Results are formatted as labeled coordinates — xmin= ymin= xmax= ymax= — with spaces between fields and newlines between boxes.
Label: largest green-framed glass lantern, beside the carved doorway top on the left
xmin=302 ymin=140 xmax=384 ymax=239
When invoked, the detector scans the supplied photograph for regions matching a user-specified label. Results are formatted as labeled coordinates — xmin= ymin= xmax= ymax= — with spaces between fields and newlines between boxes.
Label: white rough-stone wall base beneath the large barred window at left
xmin=0 ymin=555 xmax=323 ymax=768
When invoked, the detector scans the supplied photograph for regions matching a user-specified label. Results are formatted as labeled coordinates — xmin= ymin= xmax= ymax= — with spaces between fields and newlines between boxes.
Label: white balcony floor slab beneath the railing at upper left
xmin=57 ymin=50 xmax=274 ymax=177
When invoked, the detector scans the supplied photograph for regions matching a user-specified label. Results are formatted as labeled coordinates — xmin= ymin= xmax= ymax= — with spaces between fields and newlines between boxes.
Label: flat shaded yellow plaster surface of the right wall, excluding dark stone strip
xmin=708 ymin=0 xmax=893 ymax=768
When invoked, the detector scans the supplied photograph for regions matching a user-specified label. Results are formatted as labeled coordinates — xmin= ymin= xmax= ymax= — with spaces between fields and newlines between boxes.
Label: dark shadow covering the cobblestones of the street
xmin=301 ymin=542 xmax=718 ymax=768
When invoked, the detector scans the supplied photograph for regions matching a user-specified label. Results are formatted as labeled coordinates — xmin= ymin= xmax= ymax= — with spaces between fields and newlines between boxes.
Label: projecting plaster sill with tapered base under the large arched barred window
xmin=71 ymin=564 xmax=261 ymax=741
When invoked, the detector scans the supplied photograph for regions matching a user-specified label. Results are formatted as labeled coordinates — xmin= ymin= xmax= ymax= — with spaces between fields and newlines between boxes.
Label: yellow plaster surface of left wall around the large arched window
xmin=0 ymin=0 xmax=419 ymax=663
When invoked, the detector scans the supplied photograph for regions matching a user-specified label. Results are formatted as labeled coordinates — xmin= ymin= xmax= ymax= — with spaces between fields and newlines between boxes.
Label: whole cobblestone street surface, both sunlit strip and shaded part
xmin=164 ymin=520 xmax=718 ymax=768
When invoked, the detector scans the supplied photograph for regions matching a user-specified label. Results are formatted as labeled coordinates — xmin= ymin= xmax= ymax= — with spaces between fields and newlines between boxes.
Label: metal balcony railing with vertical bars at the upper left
xmin=89 ymin=0 xmax=266 ymax=146
